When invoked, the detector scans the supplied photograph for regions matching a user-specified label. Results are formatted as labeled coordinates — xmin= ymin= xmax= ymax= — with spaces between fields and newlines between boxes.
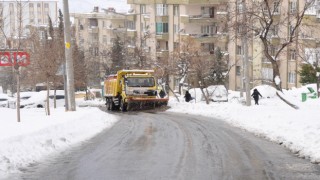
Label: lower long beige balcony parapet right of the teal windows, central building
xmin=181 ymin=34 xmax=228 ymax=43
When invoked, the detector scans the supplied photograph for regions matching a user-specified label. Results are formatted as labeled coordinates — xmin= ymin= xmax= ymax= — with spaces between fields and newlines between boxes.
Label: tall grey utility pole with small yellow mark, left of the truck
xmin=63 ymin=0 xmax=76 ymax=111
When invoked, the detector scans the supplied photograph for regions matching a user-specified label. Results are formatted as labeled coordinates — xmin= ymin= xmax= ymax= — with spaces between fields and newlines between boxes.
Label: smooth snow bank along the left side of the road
xmin=0 ymin=107 xmax=117 ymax=177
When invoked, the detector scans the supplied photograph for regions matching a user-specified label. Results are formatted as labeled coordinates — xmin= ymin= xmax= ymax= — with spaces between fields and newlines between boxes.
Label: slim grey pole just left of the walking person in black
xmin=242 ymin=0 xmax=251 ymax=106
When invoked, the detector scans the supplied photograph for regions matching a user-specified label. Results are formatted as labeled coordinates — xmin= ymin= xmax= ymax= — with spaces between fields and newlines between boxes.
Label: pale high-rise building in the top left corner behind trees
xmin=0 ymin=0 xmax=58 ymax=49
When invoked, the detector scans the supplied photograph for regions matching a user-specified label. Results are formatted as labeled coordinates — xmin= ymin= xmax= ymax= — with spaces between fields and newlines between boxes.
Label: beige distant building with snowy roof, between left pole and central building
xmin=70 ymin=7 xmax=127 ymax=87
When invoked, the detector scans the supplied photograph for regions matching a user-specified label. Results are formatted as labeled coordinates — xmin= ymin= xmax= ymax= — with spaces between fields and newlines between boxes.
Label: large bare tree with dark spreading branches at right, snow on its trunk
xmin=233 ymin=0 xmax=314 ymax=91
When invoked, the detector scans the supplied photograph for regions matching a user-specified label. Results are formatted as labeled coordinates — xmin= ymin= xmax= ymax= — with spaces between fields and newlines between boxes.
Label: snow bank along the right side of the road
xmin=168 ymin=86 xmax=320 ymax=163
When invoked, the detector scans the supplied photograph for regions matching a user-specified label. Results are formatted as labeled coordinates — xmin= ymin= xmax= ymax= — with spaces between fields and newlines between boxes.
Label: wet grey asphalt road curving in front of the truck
xmin=6 ymin=111 xmax=320 ymax=180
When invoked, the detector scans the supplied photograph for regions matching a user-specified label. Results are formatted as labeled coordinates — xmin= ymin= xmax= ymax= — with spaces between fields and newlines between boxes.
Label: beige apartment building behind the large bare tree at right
xmin=228 ymin=0 xmax=320 ymax=90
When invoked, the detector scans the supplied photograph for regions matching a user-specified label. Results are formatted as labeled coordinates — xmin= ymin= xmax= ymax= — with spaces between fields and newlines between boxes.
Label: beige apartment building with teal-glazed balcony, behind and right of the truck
xmin=127 ymin=0 xmax=228 ymax=89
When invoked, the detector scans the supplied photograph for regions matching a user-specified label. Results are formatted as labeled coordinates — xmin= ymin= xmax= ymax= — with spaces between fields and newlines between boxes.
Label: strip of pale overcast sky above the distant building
xmin=58 ymin=0 xmax=129 ymax=13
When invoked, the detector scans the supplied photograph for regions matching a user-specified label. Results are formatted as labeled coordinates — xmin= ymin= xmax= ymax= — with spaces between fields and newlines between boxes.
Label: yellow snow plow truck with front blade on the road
xmin=104 ymin=70 xmax=169 ymax=111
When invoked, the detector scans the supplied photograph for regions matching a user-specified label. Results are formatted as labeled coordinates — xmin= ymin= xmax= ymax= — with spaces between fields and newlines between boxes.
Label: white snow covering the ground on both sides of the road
xmin=0 ymin=85 xmax=320 ymax=179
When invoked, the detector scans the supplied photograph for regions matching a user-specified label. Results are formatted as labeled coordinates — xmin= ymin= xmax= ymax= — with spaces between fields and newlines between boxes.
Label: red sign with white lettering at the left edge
xmin=0 ymin=52 xmax=30 ymax=66
